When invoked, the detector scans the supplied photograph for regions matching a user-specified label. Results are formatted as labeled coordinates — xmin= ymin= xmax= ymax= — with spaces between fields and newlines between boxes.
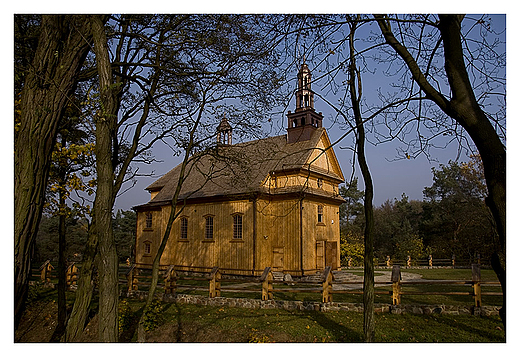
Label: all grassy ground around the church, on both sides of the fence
xmin=17 ymin=269 xmax=505 ymax=342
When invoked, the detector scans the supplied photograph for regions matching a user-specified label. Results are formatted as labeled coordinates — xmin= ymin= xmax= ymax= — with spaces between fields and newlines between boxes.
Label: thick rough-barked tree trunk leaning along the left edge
xmin=14 ymin=15 xmax=90 ymax=327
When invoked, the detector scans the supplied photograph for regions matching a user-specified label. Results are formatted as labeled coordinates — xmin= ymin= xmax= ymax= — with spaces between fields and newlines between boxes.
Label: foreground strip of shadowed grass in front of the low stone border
xmin=121 ymin=302 xmax=505 ymax=342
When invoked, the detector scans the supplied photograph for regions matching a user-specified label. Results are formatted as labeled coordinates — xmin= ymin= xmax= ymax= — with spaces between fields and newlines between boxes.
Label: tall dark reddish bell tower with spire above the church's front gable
xmin=287 ymin=62 xmax=323 ymax=144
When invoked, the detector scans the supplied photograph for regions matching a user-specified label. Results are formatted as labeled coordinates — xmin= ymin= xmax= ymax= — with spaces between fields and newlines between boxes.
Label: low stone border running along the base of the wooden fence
xmin=124 ymin=291 xmax=500 ymax=316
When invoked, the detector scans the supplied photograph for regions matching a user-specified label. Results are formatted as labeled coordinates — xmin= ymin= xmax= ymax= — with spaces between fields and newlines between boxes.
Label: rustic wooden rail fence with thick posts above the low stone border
xmin=126 ymin=264 xmax=502 ymax=307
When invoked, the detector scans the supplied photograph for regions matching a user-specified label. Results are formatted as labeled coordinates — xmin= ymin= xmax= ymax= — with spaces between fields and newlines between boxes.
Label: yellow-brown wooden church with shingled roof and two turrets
xmin=134 ymin=64 xmax=344 ymax=276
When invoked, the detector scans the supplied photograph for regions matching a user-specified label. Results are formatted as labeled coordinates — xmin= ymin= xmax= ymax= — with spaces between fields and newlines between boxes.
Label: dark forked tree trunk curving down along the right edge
xmin=374 ymin=15 xmax=506 ymax=327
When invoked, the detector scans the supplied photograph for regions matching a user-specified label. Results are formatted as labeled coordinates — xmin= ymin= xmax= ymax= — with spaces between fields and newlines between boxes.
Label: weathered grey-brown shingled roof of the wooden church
xmin=136 ymin=128 xmax=343 ymax=207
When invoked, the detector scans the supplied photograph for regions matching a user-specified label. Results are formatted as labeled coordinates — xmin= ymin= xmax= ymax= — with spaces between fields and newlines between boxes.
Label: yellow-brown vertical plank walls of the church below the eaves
xmin=136 ymin=199 xmax=339 ymax=274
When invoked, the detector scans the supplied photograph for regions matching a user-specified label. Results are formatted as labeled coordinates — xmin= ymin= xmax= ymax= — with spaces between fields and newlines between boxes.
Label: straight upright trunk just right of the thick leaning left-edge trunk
xmin=91 ymin=16 xmax=119 ymax=342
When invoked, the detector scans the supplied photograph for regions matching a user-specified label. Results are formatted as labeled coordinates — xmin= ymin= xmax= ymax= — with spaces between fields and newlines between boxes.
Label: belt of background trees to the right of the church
xmin=340 ymin=156 xmax=496 ymax=266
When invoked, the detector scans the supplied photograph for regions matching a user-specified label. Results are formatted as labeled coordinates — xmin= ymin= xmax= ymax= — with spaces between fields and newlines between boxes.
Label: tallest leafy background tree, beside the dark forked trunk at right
xmin=421 ymin=156 xmax=497 ymax=262
